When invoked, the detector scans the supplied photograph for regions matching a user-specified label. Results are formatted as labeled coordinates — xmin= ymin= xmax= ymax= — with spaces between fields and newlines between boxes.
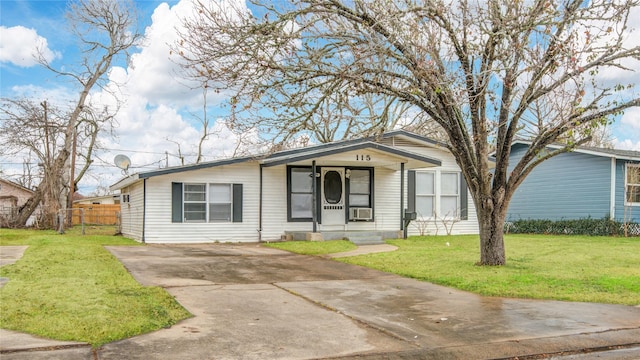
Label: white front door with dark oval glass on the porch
xmin=320 ymin=167 xmax=346 ymax=225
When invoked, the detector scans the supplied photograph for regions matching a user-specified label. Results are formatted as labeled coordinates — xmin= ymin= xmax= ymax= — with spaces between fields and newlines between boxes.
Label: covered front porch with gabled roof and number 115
xmin=261 ymin=141 xmax=441 ymax=244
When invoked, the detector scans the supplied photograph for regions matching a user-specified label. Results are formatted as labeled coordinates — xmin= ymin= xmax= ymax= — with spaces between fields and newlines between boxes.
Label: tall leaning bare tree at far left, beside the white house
xmin=3 ymin=0 xmax=141 ymax=228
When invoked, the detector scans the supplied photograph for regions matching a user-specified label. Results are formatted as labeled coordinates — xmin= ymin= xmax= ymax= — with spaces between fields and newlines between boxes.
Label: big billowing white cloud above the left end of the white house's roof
xmin=84 ymin=0 xmax=257 ymax=191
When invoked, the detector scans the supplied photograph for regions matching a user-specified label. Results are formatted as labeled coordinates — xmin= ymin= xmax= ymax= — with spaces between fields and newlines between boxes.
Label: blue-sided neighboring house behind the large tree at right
xmin=507 ymin=141 xmax=640 ymax=223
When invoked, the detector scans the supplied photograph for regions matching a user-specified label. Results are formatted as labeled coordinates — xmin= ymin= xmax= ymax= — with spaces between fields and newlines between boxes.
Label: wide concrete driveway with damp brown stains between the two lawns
xmin=97 ymin=244 xmax=640 ymax=359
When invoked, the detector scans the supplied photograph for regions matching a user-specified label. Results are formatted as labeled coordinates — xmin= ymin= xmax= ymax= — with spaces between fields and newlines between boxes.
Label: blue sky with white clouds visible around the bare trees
xmin=0 ymin=0 xmax=640 ymax=195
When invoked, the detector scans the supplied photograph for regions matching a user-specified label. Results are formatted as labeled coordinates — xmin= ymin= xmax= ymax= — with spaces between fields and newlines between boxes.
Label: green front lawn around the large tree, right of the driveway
xmin=272 ymin=235 xmax=640 ymax=305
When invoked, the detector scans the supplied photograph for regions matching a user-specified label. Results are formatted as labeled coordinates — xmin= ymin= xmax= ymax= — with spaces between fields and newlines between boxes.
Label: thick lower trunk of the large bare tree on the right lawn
xmin=478 ymin=208 xmax=506 ymax=266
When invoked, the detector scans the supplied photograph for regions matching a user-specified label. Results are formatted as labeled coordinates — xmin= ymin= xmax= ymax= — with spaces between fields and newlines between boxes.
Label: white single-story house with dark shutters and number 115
xmin=111 ymin=130 xmax=478 ymax=243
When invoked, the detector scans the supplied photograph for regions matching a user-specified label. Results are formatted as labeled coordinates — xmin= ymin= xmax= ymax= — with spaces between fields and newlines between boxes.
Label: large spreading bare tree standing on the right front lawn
xmin=176 ymin=0 xmax=640 ymax=265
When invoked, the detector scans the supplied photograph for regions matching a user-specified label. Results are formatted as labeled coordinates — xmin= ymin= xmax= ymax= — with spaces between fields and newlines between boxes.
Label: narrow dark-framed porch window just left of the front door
xmin=288 ymin=167 xmax=314 ymax=221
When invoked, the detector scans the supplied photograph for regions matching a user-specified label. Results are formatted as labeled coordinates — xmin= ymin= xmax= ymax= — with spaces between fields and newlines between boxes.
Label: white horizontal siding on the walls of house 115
xmin=115 ymin=134 xmax=478 ymax=243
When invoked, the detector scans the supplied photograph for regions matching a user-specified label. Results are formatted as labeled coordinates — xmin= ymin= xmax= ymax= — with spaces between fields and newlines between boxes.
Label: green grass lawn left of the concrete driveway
xmin=0 ymin=228 xmax=191 ymax=347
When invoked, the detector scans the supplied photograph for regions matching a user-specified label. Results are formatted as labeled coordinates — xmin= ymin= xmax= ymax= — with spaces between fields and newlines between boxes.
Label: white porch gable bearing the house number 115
xmin=261 ymin=142 xmax=441 ymax=170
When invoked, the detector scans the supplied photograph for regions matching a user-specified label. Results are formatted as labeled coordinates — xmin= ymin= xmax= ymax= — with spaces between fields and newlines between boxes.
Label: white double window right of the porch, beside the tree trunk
xmin=415 ymin=171 xmax=461 ymax=218
